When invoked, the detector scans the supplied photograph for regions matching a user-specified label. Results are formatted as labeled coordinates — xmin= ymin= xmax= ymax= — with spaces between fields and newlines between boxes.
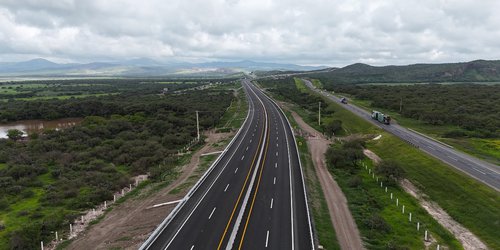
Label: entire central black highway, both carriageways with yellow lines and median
xmin=141 ymin=79 xmax=315 ymax=250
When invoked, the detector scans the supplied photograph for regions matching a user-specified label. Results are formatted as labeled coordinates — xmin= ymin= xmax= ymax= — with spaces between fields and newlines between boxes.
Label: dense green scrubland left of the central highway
xmin=0 ymin=79 xmax=235 ymax=249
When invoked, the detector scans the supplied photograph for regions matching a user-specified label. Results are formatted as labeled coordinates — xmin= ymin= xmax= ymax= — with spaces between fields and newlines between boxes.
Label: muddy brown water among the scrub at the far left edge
xmin=0 ymin=118 xmax=83 ymax=138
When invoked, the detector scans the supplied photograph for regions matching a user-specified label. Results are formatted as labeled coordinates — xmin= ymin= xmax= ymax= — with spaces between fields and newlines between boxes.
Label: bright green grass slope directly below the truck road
xmin=264 ymin=79 xmax=500 ymax=249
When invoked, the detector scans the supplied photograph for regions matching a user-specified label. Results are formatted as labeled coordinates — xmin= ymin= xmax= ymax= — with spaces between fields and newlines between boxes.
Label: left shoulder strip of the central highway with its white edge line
xmin=139 ymin=80 xmax=253 ymax=250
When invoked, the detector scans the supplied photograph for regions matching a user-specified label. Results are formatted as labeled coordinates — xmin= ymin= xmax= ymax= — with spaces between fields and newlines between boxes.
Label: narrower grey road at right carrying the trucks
xmin=302 ymin=79 xmax=500 ymax=191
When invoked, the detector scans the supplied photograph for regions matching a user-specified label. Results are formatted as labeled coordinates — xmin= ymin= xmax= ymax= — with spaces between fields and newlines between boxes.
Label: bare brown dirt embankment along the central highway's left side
xmin=67 ymin=130 xmax=232 ymax=250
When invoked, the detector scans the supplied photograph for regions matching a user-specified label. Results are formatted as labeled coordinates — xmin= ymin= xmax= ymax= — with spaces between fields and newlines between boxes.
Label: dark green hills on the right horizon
xmin=309 ymin=60 xmax=500 ymax=83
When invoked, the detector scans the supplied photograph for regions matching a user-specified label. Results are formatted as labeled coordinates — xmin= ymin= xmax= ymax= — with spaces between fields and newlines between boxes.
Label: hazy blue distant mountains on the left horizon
xmin=0 ymin=58 xmax=325 ymax=77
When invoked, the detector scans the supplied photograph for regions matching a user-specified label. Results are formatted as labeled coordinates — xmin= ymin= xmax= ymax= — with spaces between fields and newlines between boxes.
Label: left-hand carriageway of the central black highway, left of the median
xmin=143 ymin=80 xmax=266 ymax=249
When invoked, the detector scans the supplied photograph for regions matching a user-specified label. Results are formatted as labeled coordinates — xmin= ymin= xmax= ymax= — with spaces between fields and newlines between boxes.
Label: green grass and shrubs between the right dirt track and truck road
xmin=259 ymin=79 xmax=500 ymax=249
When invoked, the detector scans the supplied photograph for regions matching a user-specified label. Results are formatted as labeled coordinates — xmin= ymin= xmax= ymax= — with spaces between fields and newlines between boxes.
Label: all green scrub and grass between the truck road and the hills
xmin=316 ymin=81 xmax=500 ymax=164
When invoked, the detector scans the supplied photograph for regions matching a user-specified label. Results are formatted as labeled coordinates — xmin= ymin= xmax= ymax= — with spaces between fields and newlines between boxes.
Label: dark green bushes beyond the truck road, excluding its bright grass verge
xmin=327 ymin=84 xmax=500 ymax=138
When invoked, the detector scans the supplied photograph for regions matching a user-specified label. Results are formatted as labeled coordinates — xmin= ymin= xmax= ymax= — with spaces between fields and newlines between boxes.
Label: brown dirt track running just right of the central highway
xmin=292 ymin=112 xmax=364 ymax=249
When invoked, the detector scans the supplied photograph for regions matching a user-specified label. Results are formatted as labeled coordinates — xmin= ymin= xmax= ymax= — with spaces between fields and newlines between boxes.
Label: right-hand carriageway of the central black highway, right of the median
xmin=229 ymin=82 xmax=314 ymax=249
